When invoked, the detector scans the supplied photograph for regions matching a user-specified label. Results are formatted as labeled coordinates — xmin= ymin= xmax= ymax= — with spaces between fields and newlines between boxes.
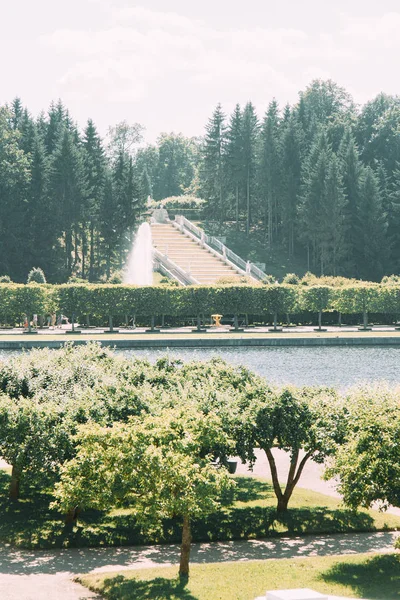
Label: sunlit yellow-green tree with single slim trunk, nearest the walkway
xmin=55 ymin=407 xmax=233 ymax=579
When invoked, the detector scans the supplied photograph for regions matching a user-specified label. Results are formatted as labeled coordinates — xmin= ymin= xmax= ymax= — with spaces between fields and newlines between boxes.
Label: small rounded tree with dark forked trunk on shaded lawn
xmin=235 ymin=387 xmax=345 ymax=513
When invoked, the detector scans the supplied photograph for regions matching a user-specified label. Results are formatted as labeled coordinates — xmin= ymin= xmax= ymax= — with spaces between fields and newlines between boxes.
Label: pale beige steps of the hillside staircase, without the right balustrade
xmin=151 ymin=223 xmax=240 ymax=285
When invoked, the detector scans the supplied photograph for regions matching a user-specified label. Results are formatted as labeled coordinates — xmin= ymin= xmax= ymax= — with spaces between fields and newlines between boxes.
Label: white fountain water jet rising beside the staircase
xmin=124 ymin=223 xmax=153 ymax=285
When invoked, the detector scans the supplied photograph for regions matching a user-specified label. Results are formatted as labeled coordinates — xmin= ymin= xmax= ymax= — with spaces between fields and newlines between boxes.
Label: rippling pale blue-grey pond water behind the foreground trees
xmin=0 ymin=346 xmax=400 ymax=389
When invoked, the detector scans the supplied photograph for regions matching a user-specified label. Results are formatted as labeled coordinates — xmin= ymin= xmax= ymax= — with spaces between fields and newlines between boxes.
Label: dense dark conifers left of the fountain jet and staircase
xmin=0 ymin=99 xmax=143 ymax=282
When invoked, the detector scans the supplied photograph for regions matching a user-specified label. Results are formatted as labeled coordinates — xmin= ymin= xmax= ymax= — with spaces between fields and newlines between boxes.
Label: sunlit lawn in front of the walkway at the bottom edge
xmin=78 ymin=554 xmax=400 ymax=600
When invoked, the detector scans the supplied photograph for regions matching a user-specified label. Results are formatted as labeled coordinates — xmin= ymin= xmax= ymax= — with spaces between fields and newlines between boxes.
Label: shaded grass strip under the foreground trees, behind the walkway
xmin=0 ymin=470 xmax=400 ymax=548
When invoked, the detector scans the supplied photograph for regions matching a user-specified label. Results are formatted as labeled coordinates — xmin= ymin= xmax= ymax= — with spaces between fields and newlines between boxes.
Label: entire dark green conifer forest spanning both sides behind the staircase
xmin=0 ymin=80 xmax=400 ymax=283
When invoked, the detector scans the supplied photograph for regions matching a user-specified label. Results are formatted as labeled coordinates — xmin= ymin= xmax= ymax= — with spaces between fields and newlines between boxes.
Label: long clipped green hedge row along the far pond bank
xmin=0 ymin=284 xmax=400 ymax=324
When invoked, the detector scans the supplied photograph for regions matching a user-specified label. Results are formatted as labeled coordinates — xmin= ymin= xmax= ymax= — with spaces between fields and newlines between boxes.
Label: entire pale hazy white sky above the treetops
xmin=0 ymin=0 xmax=400 ymax=142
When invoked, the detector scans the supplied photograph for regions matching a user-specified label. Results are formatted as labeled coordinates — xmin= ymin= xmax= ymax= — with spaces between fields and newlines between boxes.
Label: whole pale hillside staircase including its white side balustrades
xmin=151 ymin=217 xmax=264 ymax=285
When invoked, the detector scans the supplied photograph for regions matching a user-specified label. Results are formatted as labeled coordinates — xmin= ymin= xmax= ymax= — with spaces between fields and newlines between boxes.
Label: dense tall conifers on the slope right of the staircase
xmin=195 ymin=81 xmax=400 ymax=279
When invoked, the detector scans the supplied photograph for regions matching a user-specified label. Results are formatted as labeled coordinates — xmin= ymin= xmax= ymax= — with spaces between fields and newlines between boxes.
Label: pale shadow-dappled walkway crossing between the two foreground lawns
xmin=0 ymin=532 xmax=398 ymax=600
